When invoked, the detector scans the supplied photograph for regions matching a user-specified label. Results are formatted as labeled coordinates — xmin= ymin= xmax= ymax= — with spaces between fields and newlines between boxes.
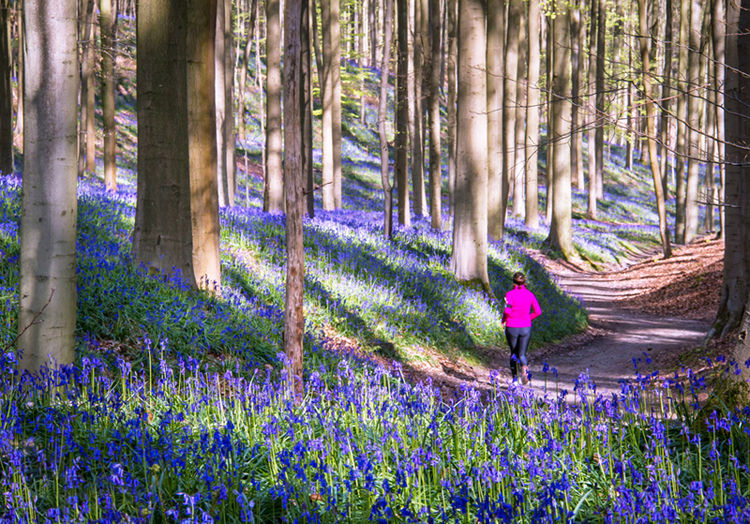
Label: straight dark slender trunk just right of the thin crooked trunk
xmin=395 ymin=0 xmax=411 ymax=227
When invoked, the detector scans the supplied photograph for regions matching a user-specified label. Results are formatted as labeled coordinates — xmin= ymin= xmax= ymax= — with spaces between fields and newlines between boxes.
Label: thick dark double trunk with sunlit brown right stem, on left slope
xmin=133 ymin=0 xmax=221 ymax=291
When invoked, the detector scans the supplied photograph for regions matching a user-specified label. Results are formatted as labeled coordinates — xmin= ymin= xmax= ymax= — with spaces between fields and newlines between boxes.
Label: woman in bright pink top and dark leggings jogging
xmin=503 ymin=273 xmax=542 ymax=384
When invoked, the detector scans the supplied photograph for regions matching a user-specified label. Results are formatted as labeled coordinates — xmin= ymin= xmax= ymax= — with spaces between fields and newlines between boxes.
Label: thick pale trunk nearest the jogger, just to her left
xmin=451 ymin=0 xmax=496 ymax=294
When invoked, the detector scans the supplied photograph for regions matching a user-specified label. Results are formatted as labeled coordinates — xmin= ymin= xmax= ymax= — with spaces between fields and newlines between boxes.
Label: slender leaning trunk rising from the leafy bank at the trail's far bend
xmin=638 ymin=0 xmax=672 ymax=258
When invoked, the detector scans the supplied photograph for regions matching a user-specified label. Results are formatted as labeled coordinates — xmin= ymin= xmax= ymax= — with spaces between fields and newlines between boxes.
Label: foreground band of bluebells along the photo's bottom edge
xmin=0 ymin=343 xmax=750 ymax=522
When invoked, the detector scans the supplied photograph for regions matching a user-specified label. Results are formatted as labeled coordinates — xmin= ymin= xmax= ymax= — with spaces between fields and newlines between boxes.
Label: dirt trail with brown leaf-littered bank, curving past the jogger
xmin=405 ymin=240 xmax=724 ymax=401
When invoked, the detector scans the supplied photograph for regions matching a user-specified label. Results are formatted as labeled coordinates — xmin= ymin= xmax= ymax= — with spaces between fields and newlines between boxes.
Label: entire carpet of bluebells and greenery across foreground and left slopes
xmin=0 ymin=56 xmax=750 ymax=522
